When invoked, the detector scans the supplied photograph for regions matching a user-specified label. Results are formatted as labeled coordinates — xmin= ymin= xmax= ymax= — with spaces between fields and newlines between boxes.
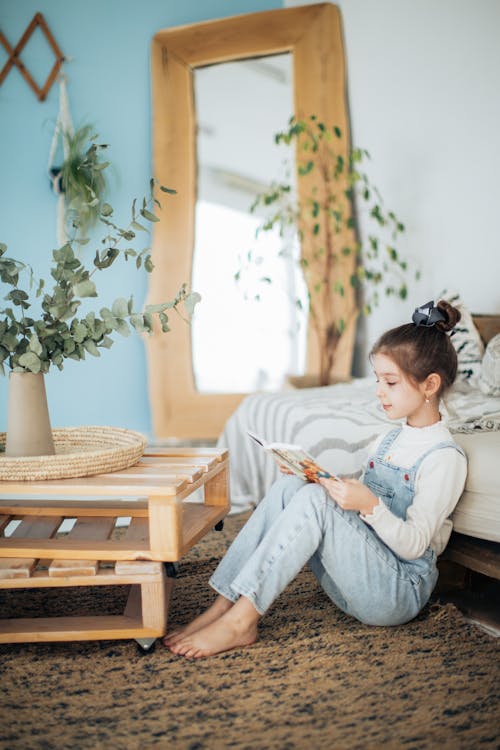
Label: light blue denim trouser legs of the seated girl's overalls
xmin=210 ymin=475 xmax=437 ymax=625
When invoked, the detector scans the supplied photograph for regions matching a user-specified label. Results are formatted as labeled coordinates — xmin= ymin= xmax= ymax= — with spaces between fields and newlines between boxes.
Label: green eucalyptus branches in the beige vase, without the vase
xmin=0 ymin=180 xmax=200 ymax=374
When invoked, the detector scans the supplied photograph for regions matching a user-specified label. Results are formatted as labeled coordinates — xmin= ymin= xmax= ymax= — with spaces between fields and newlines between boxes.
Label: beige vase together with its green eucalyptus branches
xmin=0 ymin=163 xmax=199 ymax=456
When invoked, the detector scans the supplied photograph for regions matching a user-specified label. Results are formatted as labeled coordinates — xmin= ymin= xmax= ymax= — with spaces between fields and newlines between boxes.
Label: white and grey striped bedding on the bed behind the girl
xmin=219 ymin=377 xmax=500 ymax=535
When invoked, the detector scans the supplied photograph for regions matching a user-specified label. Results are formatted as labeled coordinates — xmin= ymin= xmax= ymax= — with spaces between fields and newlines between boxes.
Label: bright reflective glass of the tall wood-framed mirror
xmin=192 ymin=54 xmax=307 ymax=393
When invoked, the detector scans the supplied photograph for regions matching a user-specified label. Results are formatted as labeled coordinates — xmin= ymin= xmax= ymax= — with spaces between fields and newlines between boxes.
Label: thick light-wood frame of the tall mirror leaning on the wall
xmin=147 ymin=3 xmax=355 ymax=439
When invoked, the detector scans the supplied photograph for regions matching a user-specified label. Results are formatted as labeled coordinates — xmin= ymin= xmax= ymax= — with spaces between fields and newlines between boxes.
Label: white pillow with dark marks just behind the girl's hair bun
xmin=437 ymin=289 xmax=484 ymax=387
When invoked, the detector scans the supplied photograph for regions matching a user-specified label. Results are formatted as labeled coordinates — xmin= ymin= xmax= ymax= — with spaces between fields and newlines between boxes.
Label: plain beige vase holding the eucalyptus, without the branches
xmin=5 ymin=372 xmax=55 ymax=457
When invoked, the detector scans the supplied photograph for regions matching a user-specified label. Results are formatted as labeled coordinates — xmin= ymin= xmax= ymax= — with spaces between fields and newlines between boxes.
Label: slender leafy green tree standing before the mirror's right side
xmin=240 ymin=115 xmax=418 ymax=385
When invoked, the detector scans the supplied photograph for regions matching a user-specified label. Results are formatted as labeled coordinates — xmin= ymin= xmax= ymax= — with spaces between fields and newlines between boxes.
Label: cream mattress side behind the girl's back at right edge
xmin=451 ymin=431 xmax=500 ymax=542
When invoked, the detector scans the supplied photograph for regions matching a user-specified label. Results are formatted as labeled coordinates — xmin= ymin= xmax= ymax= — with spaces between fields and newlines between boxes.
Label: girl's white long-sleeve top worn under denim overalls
xmin=361 ymin=421 xmax=467 ymax=560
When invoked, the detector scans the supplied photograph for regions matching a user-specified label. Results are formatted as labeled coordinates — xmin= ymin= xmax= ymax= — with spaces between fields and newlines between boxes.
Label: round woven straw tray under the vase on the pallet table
xmin=0 ymin=427 xmax=147 ymax=484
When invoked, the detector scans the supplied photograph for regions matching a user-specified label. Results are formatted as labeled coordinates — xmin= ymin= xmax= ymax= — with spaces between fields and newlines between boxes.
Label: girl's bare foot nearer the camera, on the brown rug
xmin=169 ymin=597 xmax=259 ymax=659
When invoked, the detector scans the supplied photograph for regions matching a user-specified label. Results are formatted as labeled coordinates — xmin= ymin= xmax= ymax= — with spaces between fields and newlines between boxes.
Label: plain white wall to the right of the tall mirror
xmin=284 ymin=0 xmax=500 ymax=370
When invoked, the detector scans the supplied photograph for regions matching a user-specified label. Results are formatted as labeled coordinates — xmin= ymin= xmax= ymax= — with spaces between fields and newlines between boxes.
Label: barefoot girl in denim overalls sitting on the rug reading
xmin=164 ymin=301 xmax=467 ymax=658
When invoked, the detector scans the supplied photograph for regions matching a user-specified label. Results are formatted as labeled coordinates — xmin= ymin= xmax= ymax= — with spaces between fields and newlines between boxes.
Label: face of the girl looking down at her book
xmin=372 ymin=354 xmax=439 ymax=427
